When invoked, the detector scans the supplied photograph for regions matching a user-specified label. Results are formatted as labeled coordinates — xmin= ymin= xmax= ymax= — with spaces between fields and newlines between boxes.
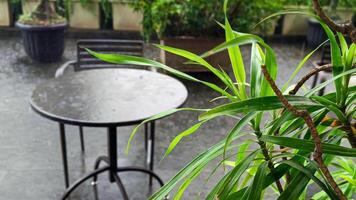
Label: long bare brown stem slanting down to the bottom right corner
xmin=261 ymin=65 xmax=346 ymax=200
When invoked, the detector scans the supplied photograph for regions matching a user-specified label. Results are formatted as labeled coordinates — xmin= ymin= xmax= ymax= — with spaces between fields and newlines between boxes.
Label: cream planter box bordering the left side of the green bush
xmin=112 ymin=1 xmax=143 ymax=31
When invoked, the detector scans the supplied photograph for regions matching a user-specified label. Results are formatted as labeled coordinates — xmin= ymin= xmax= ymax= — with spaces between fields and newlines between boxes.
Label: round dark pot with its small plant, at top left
xmin=16 ymin=0 xmax=67 ymax=62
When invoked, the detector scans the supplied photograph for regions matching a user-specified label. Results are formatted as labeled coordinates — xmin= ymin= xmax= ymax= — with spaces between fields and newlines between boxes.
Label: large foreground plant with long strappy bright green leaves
xmin=88 ymin=1 xmax=356 ymax=200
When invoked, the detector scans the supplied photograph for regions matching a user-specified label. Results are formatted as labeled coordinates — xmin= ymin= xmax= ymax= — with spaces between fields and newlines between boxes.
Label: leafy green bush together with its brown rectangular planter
xmin=133 ymin=0 xmax=281 ymax=72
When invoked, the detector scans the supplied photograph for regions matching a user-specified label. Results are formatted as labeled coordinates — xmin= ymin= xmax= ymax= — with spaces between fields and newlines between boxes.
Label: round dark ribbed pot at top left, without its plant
xmin=16 ymin=22 xmax=67 ymax=62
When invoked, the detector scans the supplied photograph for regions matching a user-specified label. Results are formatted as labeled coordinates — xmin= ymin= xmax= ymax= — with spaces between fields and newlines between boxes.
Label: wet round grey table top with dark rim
xmin=30 ymin=69 xmax=188 ymax=127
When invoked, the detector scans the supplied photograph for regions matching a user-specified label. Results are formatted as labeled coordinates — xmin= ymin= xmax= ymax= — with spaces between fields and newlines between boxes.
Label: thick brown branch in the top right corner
xmin=313 ymin=0 xmax=356 ymax=43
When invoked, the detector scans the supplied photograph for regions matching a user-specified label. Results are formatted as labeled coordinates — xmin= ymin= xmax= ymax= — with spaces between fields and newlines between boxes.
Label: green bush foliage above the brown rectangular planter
xmin=133 ymin=0 xmax=283 ymax=39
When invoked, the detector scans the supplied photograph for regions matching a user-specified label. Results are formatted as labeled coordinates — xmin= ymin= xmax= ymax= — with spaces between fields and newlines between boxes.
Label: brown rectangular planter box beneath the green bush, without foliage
xmin=161 ymin=37 xmax=230 ymax=72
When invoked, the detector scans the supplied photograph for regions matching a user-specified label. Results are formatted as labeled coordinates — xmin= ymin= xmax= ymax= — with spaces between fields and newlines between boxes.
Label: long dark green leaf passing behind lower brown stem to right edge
xmin=261 ymin=135 xmax=356 ymax=157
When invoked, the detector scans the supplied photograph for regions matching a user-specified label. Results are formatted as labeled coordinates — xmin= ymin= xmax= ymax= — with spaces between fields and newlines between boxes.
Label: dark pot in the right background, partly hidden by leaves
xmin=307 ymin=19 xmax=327 ymax=47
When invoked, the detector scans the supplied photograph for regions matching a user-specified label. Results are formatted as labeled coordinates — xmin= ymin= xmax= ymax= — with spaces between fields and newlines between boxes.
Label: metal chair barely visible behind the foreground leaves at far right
xmin=312 ymin=43 xmax=332 ymax=96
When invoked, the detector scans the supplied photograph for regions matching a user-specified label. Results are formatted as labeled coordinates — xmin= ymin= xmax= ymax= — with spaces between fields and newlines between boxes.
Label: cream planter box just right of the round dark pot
xmin=69 ymin=0 xmax=100 ymax=29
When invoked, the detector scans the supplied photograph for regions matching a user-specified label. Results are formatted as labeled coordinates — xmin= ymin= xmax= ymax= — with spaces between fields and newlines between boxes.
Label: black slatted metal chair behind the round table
xmin=55 ymin=39 xmax=155 ymax=185
